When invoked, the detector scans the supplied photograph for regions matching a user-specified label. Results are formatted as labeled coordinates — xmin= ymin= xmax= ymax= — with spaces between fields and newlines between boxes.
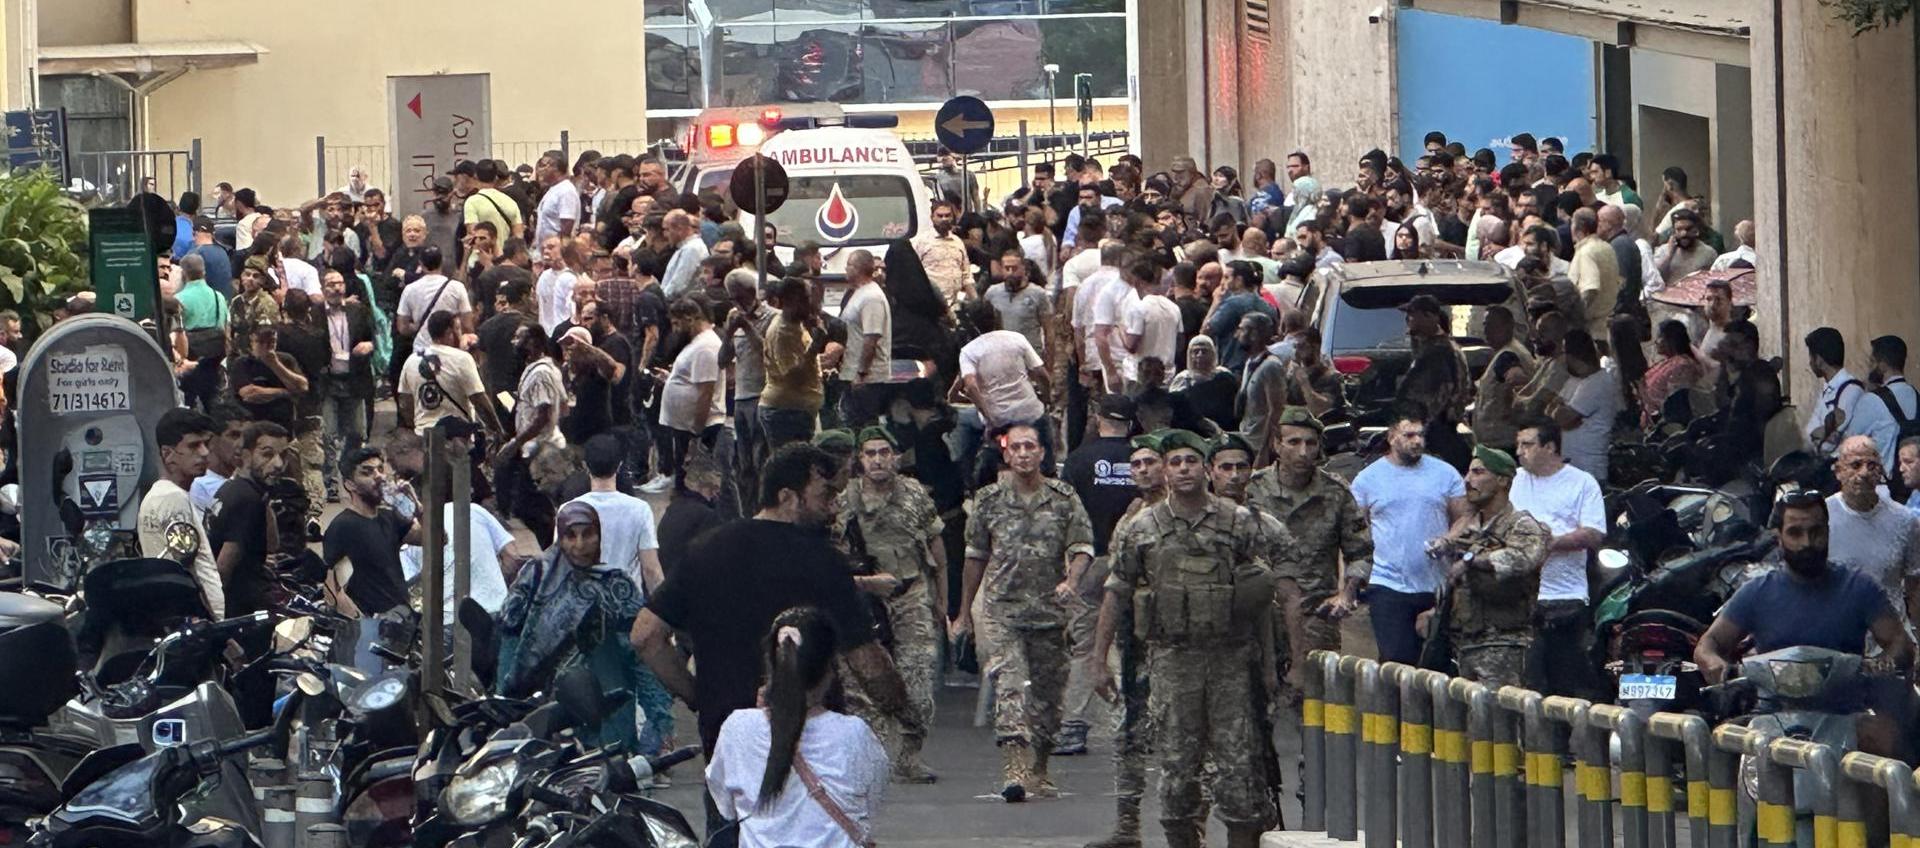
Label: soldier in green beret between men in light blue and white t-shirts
xmin=1432 ymin=445 xmax=1551 ymax=687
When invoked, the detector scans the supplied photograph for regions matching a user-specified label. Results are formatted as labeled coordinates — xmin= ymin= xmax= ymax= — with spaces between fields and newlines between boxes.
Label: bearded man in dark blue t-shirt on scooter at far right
xmin=1693 ymin=489 xmax=1914 ymax=756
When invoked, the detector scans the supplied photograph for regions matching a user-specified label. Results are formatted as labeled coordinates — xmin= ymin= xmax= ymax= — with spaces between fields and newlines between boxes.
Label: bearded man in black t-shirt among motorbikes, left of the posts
xmin=321 ymin=447 xmax=419 ymax=618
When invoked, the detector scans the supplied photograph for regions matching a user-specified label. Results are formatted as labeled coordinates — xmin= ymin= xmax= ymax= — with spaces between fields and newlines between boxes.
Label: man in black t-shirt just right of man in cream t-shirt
xmin=207 ymin=422 xmax=292 ymax=618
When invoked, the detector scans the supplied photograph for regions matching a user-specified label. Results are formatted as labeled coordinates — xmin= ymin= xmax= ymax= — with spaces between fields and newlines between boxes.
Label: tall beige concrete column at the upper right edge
xmin=1751 ymin=0 xmax=1920 ymax=411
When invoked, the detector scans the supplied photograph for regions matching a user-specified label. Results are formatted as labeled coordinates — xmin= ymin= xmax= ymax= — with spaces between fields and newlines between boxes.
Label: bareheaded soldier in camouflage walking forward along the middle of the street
xmin=954 ymin=424 xmax=1104 ymax=802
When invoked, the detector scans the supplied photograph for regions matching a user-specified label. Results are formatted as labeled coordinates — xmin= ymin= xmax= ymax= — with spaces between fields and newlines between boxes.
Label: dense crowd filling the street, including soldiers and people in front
xmin=93 ymin=132 xmax=1920 ymax=846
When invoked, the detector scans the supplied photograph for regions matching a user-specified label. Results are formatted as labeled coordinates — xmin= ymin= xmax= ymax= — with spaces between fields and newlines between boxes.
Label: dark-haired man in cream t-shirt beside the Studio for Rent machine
xmin=140 ymin=407 xmax=227 ymax=620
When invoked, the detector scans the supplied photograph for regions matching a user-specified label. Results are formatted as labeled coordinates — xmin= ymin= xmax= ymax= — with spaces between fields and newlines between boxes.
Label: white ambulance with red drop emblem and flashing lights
xmin=739 ymin=115 xmax=933 ymax=315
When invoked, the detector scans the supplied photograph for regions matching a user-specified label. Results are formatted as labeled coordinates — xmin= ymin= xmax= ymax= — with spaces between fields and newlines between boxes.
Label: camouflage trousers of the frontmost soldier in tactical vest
xmin=1146 ymin=641 xmax=1275 ymax=827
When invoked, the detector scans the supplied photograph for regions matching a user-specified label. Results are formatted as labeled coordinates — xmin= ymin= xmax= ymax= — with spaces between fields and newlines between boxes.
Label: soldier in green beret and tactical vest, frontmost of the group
xmin=1091 ymin=430 xmax=1275 ymax=848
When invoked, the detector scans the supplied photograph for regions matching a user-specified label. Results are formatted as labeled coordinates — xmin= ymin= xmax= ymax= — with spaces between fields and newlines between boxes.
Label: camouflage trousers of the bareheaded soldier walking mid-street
xmin=973 ymin=612 xmax=1069 ymax=750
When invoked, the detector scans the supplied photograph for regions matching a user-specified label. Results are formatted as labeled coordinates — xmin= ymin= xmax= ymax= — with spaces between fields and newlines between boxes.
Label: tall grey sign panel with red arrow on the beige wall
xmin=386 ymin=73 xmax=493 ymax=215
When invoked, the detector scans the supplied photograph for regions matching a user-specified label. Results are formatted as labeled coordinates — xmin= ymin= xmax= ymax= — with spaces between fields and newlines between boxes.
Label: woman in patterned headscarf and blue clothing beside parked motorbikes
xmin=493 ymin=501 xmax=672 ymax=754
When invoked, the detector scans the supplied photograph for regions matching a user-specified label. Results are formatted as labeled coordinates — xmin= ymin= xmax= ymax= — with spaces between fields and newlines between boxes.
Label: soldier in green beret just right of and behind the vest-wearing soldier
xmin=1248 ymin=407 xmax=1373 ymax=693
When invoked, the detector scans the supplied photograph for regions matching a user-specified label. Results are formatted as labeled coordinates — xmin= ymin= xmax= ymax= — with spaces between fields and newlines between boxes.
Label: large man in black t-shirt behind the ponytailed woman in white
xmin=632 ymin=443 xmax=922 ymax=760
